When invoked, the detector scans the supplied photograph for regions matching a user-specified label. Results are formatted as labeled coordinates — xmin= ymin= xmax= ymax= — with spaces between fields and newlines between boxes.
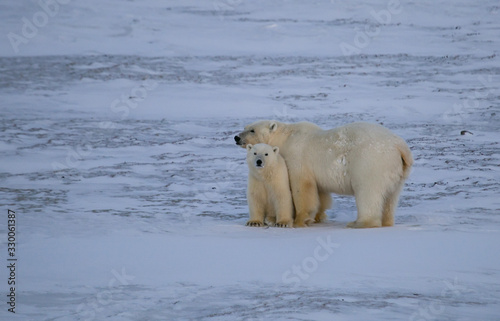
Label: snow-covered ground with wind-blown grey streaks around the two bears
xmin=0 ymin=0 xmax=500 ymax=320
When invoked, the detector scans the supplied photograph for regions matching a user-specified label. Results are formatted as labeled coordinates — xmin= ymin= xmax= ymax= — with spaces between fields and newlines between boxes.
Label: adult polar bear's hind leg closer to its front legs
xmin=347 ymin=190 xmax=384 ymax=228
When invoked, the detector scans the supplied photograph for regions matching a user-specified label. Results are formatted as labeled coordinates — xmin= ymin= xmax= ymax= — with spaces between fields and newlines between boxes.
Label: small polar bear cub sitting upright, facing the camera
xmin=246 ymin=144 xmax=294 ymax=227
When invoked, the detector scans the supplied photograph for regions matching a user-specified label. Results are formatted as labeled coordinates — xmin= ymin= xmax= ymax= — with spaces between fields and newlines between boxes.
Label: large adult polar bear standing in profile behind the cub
xmin=234 ymin=120 xmax=413 ymax=228
